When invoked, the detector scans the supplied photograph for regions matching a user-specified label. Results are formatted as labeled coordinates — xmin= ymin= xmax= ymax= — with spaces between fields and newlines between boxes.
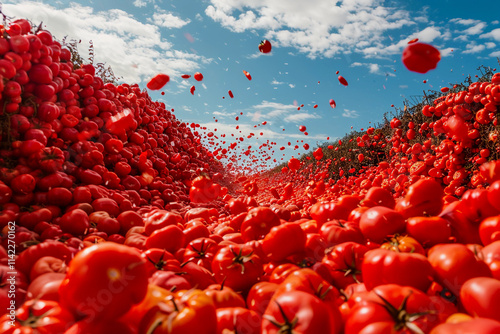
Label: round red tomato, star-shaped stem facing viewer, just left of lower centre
xmin=212 ymin=245 xmax=264 ymax=291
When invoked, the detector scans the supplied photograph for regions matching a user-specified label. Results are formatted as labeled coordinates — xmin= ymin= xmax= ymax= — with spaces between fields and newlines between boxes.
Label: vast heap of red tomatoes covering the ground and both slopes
xmin=0 ymin=19 xmax=500 ymax=334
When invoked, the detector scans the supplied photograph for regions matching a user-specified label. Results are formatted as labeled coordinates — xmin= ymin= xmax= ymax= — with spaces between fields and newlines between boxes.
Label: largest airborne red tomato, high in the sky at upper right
xmin=402 ymin=43 xmax=441 ymax=73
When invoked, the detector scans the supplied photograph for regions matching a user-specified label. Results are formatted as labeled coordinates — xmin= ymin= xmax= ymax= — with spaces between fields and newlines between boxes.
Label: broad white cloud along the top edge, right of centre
xmin=205 ymin=0 xmax=415 ymax=58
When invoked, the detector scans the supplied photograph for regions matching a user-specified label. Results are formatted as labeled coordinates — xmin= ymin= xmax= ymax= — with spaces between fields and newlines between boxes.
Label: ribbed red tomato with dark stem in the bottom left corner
xmin=0 ymin=299 xmax=74 ymax=334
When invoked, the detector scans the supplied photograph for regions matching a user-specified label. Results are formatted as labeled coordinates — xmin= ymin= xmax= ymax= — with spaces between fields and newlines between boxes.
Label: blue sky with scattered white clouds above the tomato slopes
xmin=3 ymin=0 xmax=500 ymax=172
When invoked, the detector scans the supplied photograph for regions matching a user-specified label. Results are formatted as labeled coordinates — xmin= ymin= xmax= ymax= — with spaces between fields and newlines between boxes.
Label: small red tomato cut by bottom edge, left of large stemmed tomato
xmin=217 ymin=307 xmax=262 ymax=334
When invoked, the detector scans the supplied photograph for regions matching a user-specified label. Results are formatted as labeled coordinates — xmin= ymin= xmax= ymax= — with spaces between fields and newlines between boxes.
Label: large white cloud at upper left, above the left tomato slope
xmin=2 ymin=1 xmax=211 ymax=87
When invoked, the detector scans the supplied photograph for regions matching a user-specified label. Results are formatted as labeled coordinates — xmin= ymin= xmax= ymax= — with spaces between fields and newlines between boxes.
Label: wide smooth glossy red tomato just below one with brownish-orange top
xmin=361 ymin=249 xmax=433 ymax=292
